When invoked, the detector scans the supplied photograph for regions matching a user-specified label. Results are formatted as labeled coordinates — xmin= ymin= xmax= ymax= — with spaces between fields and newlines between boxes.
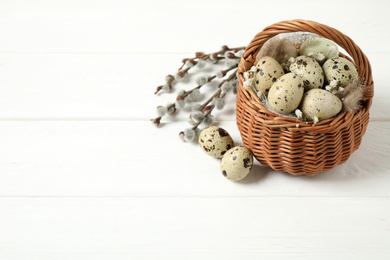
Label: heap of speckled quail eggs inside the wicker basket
xmin=248 ymin=36 xmax=358 ymax=122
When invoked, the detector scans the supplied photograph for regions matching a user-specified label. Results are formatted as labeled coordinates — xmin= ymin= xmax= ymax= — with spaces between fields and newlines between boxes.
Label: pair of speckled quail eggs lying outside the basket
xmin=199 ymin=126 xmax=253 ymax=181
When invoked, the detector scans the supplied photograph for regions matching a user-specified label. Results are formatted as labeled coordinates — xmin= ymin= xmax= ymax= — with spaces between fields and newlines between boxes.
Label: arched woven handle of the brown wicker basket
xmin=238 ymin=20 xmax=374 ymax=105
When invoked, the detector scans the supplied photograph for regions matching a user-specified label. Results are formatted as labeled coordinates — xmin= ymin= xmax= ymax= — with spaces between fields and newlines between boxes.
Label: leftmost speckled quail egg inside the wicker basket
xmin=255 ymin=56 xmax=284 ymax=96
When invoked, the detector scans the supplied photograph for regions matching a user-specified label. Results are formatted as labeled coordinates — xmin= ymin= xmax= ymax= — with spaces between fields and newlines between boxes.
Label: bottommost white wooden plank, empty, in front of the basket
xmin=0 ymin=197 xmax=390 ymax=260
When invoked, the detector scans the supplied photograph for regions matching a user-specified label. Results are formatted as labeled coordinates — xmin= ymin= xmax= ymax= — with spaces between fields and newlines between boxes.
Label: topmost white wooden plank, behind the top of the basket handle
xmin=0 ymin=0 xmax=390 ymax=53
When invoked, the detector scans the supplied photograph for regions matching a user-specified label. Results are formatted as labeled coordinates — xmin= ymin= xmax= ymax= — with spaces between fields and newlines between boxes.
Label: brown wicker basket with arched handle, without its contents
xmin=236 ymin=20 xmax=374 ymax=175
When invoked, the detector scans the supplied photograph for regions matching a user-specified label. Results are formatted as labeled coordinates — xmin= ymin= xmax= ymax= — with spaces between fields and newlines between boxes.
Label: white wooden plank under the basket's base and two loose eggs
xmin=0 ymin=121 xmax=390 ymax=197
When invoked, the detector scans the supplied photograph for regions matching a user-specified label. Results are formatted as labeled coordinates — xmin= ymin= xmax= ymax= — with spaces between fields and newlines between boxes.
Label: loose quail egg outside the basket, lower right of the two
xmin=220 ymin=146 xmax=253 ymax=181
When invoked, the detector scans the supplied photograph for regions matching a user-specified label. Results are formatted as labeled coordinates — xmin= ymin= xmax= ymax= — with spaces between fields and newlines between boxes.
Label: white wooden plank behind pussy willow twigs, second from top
xmin=0 ymin=53 xmax=390 ymax=120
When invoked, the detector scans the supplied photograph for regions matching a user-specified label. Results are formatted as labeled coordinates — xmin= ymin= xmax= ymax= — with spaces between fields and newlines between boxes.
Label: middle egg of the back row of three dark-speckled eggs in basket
xmin=290 ymin=56 xmax=324 ymax=91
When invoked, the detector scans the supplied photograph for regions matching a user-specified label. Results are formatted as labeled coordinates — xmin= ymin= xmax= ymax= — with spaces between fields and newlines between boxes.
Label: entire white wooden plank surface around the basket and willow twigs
xmin=0 ymin=0 xmax=390 ymax=260
